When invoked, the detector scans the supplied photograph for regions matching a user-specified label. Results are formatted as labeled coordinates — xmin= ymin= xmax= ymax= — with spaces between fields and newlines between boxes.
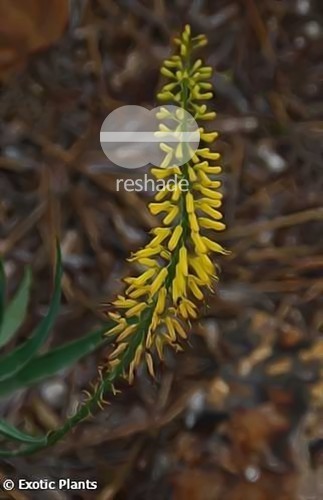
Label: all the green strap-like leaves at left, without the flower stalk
xmin=0 ymin=246 xmax=107 ymax=456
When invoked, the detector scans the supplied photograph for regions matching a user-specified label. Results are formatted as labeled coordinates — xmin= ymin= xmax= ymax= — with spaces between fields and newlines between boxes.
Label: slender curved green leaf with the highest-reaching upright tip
xmin=0 ymin=247 xmax=62 ymax=381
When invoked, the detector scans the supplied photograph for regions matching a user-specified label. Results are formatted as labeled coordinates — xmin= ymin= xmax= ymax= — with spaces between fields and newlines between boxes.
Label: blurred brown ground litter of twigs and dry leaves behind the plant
xmin=0 ymin=0 xmax=323 ymax=500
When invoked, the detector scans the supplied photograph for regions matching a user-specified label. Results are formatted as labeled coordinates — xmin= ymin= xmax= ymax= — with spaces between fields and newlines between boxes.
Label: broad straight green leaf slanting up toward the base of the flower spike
xmin=0 ymin=325 xmax=113 ymax=396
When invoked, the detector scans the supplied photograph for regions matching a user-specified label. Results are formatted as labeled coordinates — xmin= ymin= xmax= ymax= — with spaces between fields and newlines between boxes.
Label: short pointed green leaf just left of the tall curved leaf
xmin=0 ymin=268 xmax=31 ymax=347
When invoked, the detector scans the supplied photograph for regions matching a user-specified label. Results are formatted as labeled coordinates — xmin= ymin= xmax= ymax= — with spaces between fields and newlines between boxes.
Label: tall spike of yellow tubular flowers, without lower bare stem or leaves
xmin=102 ymin=26 xmax=228 ymax=382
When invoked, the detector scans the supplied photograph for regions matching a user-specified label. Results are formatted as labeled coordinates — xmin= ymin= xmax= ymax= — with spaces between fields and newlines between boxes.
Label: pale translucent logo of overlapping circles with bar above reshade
xmin=100 ymin=106 xmax=200 ymax=169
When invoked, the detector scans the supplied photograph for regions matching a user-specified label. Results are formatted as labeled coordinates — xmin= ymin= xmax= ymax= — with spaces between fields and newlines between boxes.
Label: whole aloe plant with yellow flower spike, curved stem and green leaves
xmin=0 ymin=26 xmax=228 ymax=456
